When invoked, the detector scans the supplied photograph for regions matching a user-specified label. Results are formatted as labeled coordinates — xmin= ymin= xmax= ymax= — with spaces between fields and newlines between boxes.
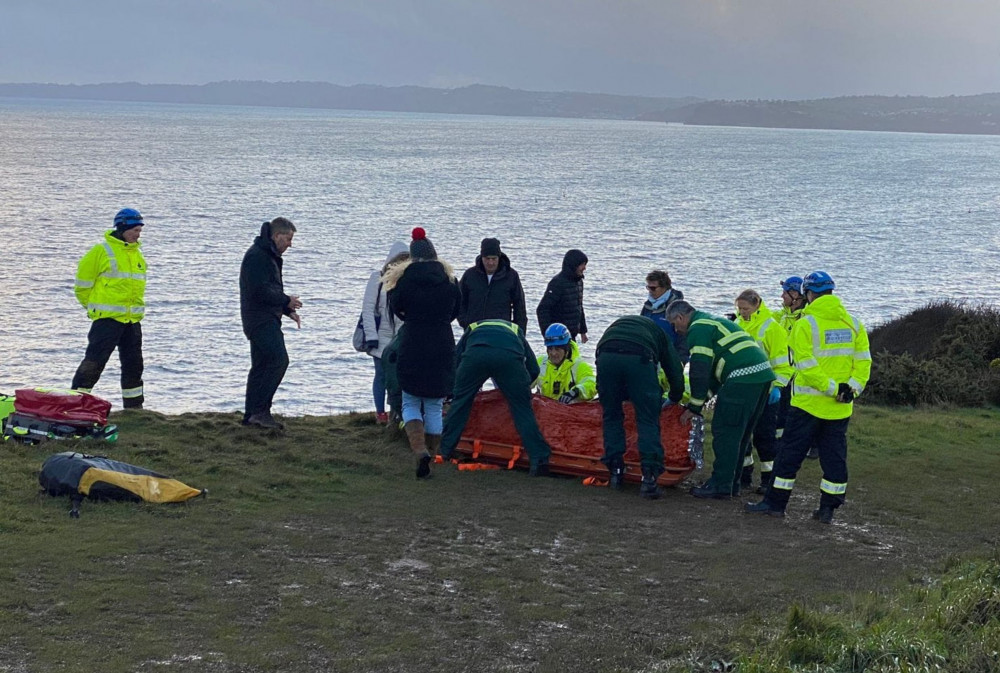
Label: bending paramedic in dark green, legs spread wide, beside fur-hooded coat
xmin=441 ymin=320 xmax=552 ymax=477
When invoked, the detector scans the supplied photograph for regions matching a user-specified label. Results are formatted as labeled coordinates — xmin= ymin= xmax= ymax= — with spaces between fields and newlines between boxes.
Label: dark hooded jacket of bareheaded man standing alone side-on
xmin=240 ymin=222 xmax=291 ymax=339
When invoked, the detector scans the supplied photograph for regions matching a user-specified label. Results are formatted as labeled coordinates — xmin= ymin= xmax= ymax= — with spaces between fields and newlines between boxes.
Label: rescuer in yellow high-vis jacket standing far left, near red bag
xmin=72 ymin=208 xmax=147 ymax=409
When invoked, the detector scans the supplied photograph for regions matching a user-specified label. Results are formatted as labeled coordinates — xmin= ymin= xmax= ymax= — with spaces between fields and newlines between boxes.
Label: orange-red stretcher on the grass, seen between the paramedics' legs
xmin=456 ymin=390 xmax=695 ymax=486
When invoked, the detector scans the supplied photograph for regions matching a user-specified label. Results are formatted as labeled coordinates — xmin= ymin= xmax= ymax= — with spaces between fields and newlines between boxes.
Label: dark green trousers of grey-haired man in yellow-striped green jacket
xmin=707 ymin=381 xmax=771 ymax=495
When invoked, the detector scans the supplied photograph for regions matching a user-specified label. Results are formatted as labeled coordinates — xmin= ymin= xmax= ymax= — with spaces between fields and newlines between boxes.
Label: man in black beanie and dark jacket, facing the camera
xmin=458 ymin=238 xmax=528 ymax=332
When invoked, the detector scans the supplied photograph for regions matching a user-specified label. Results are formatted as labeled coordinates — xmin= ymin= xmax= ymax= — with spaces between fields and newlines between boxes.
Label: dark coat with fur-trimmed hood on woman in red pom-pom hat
xmin=382 ymin=260 xmax=462 ymax=397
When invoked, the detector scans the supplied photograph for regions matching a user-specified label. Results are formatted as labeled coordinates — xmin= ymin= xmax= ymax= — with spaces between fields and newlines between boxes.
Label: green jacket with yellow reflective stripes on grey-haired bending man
xmin=687 ymin=311 xmax=775 ymax=414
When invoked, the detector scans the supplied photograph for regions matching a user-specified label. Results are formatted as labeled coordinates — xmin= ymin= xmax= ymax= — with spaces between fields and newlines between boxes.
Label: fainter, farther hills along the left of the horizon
xmin=0 ymin=81 xmax=699 ymax=119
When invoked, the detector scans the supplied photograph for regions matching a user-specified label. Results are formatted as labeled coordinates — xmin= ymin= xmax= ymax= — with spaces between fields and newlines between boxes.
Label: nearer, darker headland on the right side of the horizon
xmin=640 ymin=93 xmax=1000 ymax=134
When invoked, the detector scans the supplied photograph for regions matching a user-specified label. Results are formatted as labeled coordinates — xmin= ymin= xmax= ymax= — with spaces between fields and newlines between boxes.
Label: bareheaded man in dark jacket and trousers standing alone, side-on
xmin=240 ymin=217 xmax=302 ymax=430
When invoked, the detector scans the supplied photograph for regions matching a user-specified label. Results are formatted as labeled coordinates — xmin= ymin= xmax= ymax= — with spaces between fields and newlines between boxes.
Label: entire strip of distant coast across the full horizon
xmin=0 ymin=81 xmax=1000 ymax=135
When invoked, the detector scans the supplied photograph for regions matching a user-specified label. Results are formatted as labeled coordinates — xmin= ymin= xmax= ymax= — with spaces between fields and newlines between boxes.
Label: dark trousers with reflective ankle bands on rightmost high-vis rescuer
xmin=765 ymin=407 xmax=851 ymax=510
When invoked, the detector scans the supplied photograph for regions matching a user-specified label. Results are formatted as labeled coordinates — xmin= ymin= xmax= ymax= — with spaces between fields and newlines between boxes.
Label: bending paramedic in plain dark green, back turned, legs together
xmin=597 ymin=315 xmax=684 ymax=499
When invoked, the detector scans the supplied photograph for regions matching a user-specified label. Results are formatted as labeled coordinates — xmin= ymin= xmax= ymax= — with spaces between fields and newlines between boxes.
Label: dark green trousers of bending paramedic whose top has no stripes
xmin=597 ymin=351 xmax=663 ymax=476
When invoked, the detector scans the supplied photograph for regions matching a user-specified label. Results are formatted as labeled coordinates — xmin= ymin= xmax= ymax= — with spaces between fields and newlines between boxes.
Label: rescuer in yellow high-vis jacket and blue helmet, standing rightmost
xmin=744 ymin=271 xmax=872 ymax=523
